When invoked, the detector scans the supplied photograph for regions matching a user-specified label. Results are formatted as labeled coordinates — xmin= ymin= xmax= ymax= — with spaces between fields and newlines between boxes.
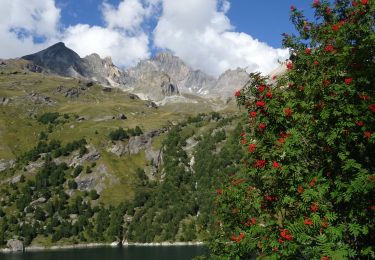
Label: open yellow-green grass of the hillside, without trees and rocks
xmin=0 ymin=61 xmax=234 ymax=204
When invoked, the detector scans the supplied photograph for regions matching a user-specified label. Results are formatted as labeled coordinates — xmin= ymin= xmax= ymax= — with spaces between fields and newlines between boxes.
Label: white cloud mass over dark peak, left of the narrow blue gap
xmin=0 ymin=0 xmax=155 ymax=66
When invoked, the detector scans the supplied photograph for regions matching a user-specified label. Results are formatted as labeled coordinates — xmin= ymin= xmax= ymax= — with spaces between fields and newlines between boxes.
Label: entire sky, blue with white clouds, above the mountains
xmin=0 ymin=0 xmax=318 ymax=76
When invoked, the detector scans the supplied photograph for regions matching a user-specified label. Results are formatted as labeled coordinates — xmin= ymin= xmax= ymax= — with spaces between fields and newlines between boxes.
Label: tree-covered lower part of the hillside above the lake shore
xmin=0 ymin=110 xmax=241 ymax=247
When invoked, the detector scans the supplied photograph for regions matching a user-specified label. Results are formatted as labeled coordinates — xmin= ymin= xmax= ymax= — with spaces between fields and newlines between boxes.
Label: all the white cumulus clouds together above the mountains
xmin=0 ymin=0 xmax=288 ymax=76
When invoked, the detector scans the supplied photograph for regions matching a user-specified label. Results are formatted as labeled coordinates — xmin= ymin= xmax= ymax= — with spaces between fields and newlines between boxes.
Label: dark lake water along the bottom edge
xmin=0 ymin=246 xmax=207 ymax=260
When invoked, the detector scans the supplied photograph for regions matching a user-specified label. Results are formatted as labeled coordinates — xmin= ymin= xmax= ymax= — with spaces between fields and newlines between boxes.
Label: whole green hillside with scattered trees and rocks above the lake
xmin=0 ymin=60 xmax=239 ymax=246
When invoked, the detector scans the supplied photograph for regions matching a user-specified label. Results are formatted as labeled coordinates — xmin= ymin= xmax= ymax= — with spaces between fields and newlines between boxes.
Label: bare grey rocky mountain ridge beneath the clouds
xmin=22 ymin=42 xmax=254 ymax=103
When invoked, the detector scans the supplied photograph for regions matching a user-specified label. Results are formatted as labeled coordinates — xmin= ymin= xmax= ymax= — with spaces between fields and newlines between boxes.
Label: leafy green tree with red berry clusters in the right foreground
xmin=211 ymin=0 xmax=375 ymax=259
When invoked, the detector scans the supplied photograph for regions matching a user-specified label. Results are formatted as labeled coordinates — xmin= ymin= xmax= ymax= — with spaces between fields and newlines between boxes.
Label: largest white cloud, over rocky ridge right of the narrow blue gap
xmin=154 ymin=0 xmax=288 ymax=76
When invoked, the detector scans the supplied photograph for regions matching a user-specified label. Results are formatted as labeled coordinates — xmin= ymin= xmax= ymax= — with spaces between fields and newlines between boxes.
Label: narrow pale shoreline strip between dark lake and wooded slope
xmin=0 ymin=241 xmax=205 ymax=253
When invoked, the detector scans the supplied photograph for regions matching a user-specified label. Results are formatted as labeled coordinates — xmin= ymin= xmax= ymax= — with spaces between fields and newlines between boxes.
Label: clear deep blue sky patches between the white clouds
xmin=56 ymin=0 xmax=312 ymax=48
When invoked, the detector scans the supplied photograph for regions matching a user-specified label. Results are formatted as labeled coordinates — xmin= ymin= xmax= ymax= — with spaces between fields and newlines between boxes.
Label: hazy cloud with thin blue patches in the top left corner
xmin=0 ymin=0 xmax=60 ymax=58
